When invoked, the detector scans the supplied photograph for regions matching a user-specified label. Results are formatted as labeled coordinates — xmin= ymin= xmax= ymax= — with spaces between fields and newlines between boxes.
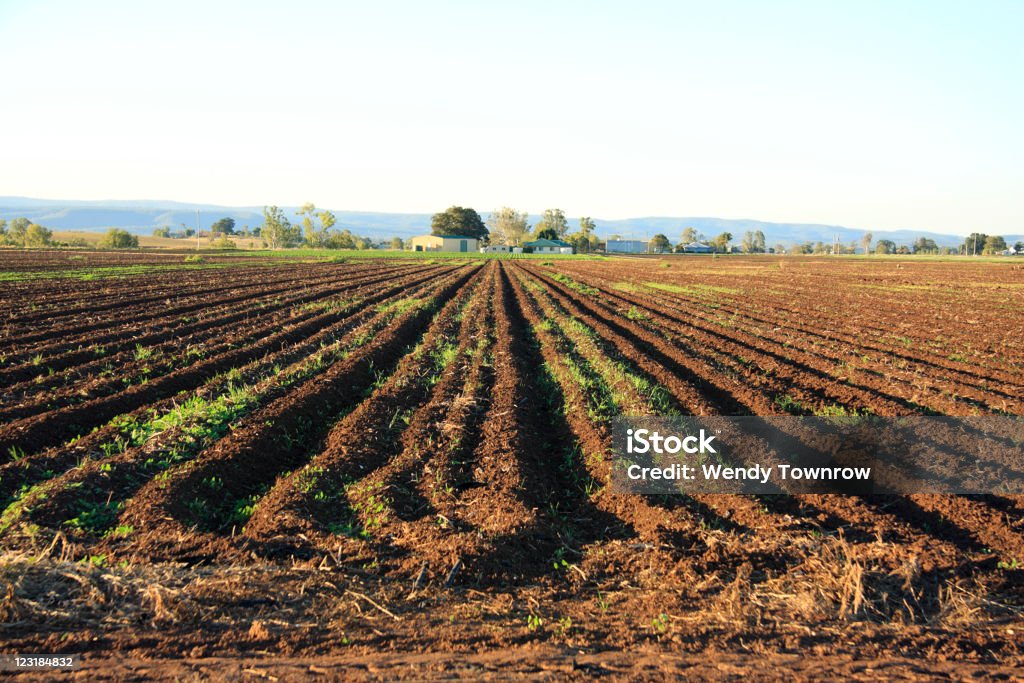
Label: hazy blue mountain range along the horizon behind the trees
xmin=0 ymin=197 xmax=1024 ymax=247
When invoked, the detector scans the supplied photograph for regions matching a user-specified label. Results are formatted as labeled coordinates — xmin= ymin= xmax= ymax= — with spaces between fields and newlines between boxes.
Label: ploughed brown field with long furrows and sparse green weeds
xmin=0 ymin=252 xmax=1024 ymax=678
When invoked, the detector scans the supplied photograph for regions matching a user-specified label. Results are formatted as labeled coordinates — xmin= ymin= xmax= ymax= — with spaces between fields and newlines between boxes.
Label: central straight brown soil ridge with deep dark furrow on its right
xmin=413 ymin=263 xmax=622 ymax=585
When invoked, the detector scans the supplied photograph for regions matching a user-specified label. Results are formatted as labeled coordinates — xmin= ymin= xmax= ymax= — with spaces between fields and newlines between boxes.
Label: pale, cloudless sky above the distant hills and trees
xmin=0 ymin=0 xmax=1024 ymax=233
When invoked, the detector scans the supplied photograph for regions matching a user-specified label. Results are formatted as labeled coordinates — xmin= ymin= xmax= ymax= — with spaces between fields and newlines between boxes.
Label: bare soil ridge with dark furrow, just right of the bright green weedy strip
xmin=112 ymin=266 xmax=479 ymax=561
